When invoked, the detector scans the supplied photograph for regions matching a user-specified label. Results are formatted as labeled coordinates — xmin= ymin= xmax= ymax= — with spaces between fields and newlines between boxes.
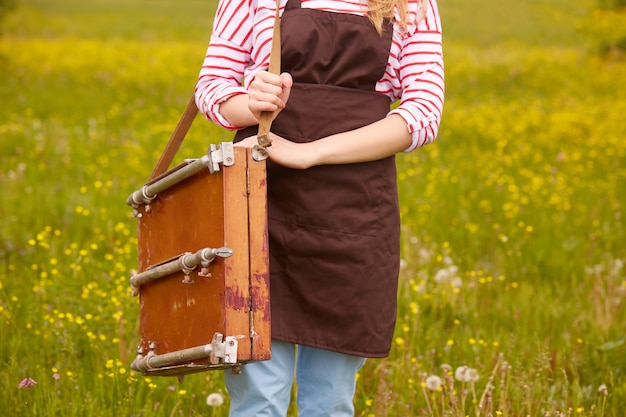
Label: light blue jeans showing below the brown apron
xmin=225 ymin=339 xmax=365 ymax=417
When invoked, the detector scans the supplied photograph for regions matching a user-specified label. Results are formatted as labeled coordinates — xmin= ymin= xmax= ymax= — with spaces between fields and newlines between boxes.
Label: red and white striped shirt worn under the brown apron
xmin=196 ymin=0 xmax=444 ymax=151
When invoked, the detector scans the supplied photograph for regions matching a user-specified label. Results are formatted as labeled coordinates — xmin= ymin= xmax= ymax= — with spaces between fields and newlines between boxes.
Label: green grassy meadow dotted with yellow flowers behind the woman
xmin=0 ymin=0 xmax=626 ymax=417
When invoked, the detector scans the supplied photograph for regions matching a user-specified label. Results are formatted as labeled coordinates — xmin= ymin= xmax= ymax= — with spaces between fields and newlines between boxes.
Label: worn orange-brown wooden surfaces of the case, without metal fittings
xmin=138 ymin=147 xmax=271 ymax=368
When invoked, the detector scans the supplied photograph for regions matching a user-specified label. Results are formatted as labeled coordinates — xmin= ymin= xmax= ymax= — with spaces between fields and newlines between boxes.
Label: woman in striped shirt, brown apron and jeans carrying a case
xmin=196 ymin=0 xmax=444 ymax=417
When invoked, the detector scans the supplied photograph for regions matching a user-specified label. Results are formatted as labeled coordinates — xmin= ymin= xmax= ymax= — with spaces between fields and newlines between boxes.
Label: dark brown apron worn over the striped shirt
xmin=235 ymin=0 xmax=400 ymax=357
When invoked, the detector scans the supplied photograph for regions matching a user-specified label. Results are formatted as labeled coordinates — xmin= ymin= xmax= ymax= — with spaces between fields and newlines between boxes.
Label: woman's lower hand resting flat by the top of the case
xmin=235 ymin=133 xmax=315 ymax=169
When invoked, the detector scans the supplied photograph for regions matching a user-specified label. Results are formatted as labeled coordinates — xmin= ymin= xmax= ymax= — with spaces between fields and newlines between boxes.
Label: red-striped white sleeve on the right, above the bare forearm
xmin=390 ymin=0 xmax=444 ymax=152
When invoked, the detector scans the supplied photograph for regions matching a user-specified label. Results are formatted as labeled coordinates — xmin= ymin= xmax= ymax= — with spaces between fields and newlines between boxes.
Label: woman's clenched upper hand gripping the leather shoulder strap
xmin=248 ymin=71 xmax=293 ymax=120
